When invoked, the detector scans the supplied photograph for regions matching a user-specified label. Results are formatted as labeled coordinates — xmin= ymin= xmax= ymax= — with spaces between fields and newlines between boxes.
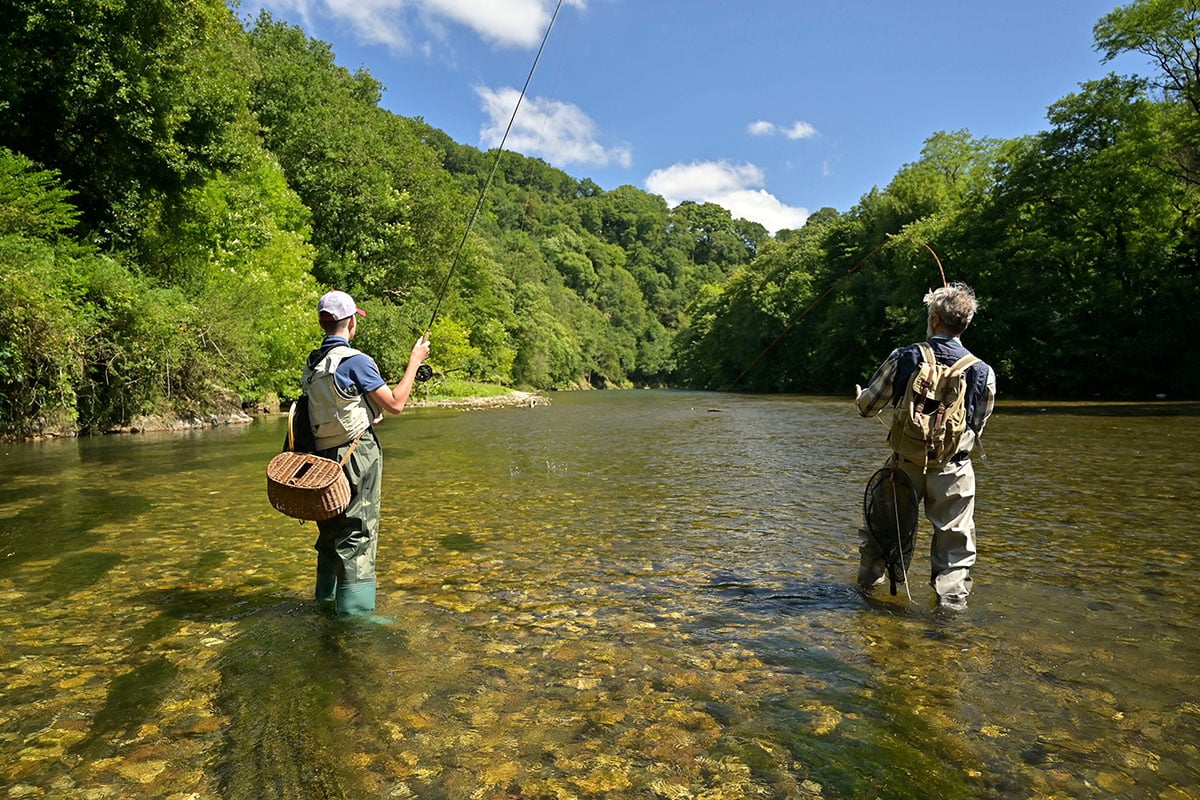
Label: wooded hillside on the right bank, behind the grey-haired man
xmin=676 ymin=0 xmax=1200 ymax=399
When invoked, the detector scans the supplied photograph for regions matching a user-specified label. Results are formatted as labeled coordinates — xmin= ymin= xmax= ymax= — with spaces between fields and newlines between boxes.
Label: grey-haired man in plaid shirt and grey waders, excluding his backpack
xmin=854 ymin=283 xmax=996 ymax=609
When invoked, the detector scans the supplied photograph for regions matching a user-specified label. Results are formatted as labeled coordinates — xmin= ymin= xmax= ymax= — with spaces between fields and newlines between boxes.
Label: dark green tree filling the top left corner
xmin=0 ymin=0 xmax=261 ymax=245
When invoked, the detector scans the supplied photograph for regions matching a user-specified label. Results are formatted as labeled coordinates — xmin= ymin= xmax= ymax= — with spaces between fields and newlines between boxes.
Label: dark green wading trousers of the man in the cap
xmin=316 ymin=431 xmax=383 ymax=614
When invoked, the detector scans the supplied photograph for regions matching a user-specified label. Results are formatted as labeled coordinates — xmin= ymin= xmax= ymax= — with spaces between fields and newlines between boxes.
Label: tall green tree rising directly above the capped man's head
xmin=251 ymin=12 xmax=467 ymax=300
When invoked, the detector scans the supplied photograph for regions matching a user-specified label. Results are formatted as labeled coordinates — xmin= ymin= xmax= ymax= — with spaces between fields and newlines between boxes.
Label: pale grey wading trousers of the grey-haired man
xmin=858 ymin=457 xmax=976 ymax=606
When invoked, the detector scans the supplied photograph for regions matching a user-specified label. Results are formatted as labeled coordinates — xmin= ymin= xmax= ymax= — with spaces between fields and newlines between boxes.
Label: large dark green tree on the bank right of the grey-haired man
xmin=972 ymin=76 xmax=1200 ymax=396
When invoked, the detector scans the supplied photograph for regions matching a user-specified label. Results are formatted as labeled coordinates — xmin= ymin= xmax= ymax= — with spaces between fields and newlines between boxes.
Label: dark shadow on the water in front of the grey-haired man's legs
xmin=692 ymin=571 xmax=1012 ymax=800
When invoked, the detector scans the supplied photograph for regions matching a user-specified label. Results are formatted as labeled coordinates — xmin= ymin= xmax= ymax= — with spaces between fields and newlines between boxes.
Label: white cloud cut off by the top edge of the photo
xmin=260 ymin=0 xmax=586 ymax=50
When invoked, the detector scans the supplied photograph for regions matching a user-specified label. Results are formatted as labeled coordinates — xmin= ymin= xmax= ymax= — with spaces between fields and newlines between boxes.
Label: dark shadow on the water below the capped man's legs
xmin=147 ymin=582 xmax=407 ymax=800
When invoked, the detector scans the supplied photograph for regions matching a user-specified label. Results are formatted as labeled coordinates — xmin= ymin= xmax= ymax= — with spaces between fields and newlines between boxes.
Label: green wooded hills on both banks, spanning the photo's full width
xmin=0 ymin=0 xmax=1200 ymax=437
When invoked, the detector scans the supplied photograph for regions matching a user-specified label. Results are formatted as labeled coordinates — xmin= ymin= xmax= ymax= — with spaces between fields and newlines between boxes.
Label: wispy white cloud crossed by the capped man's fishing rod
xmin=475 ymin=86 xmax=634 ymax=167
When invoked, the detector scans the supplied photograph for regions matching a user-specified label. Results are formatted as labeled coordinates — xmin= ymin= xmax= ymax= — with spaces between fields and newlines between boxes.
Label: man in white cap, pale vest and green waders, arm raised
xmin=302 ymin=291 xmax=430 ymax=614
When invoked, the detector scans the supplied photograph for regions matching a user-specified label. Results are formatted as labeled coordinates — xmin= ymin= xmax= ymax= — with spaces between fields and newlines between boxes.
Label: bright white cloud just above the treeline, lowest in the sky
xmin=646 ymin=161 xmax=809 ymax=233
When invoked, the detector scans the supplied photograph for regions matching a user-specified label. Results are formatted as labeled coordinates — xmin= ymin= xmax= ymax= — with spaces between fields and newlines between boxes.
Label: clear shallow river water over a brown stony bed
xmin=0 ymin=391 xmax=1200 ymax=800
